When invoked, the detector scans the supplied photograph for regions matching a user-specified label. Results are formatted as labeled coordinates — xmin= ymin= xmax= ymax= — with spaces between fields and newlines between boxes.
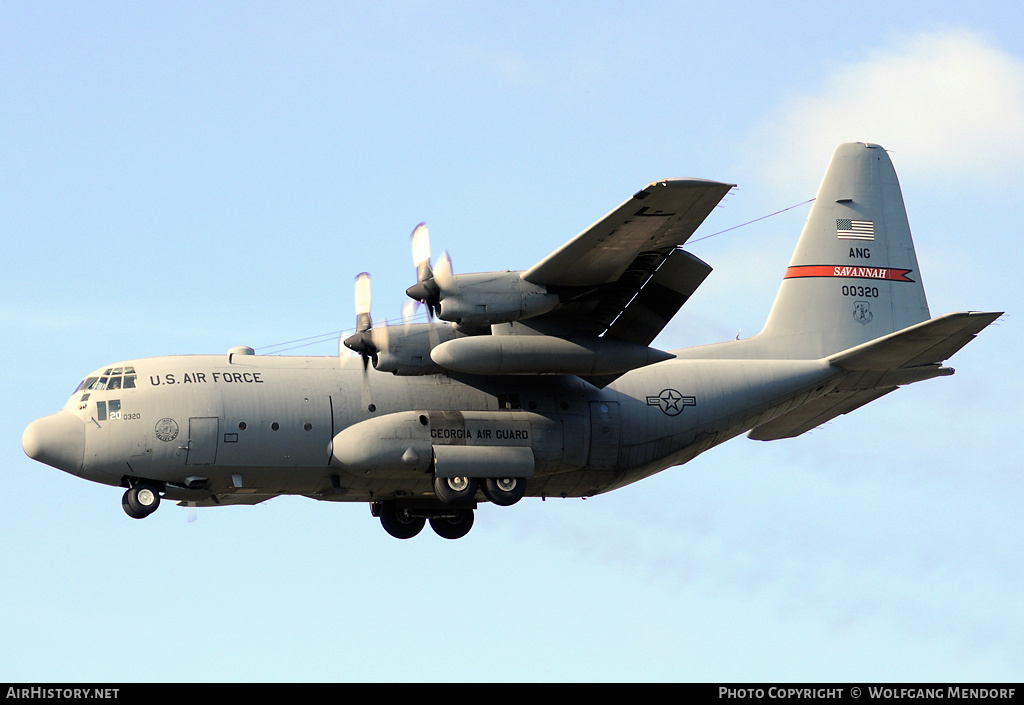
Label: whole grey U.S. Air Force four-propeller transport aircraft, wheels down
xmin=22 ymin=142 xmax=1001 ymax=539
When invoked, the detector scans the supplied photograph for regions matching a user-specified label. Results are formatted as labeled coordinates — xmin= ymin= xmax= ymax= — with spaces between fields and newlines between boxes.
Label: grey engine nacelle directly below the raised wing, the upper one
xmin=438 ymin=272 xmax=559 ymax=326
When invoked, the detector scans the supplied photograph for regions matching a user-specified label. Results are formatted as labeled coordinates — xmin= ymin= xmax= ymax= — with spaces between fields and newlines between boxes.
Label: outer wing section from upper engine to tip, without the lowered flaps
xmin=522 ymin=178 xmax=734 ymax=287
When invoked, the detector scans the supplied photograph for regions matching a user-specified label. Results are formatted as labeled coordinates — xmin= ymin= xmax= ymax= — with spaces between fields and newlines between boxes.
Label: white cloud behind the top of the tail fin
xmin=748 ymin=31 xmax=1024 ymax=191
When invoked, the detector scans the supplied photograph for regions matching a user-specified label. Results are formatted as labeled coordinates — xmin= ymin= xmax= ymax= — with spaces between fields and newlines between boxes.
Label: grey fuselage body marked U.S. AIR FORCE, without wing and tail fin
xmin=47 ymin=354 xmax=840 ymax=503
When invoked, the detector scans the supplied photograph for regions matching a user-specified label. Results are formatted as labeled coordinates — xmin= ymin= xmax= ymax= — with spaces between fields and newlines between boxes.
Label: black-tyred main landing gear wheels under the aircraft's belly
xmin=370 ymin=478 xmax=526 ymax=539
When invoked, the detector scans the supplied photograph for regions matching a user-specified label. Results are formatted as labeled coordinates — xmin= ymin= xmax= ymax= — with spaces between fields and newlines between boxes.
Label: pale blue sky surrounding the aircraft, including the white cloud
xmin=0 ymin=1 xmax=1024 ymax=681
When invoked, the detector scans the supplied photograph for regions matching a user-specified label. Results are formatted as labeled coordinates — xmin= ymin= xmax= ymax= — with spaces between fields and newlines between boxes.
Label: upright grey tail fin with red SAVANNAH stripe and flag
xmin=757 ymin=142 xmax=930 ymax=359
